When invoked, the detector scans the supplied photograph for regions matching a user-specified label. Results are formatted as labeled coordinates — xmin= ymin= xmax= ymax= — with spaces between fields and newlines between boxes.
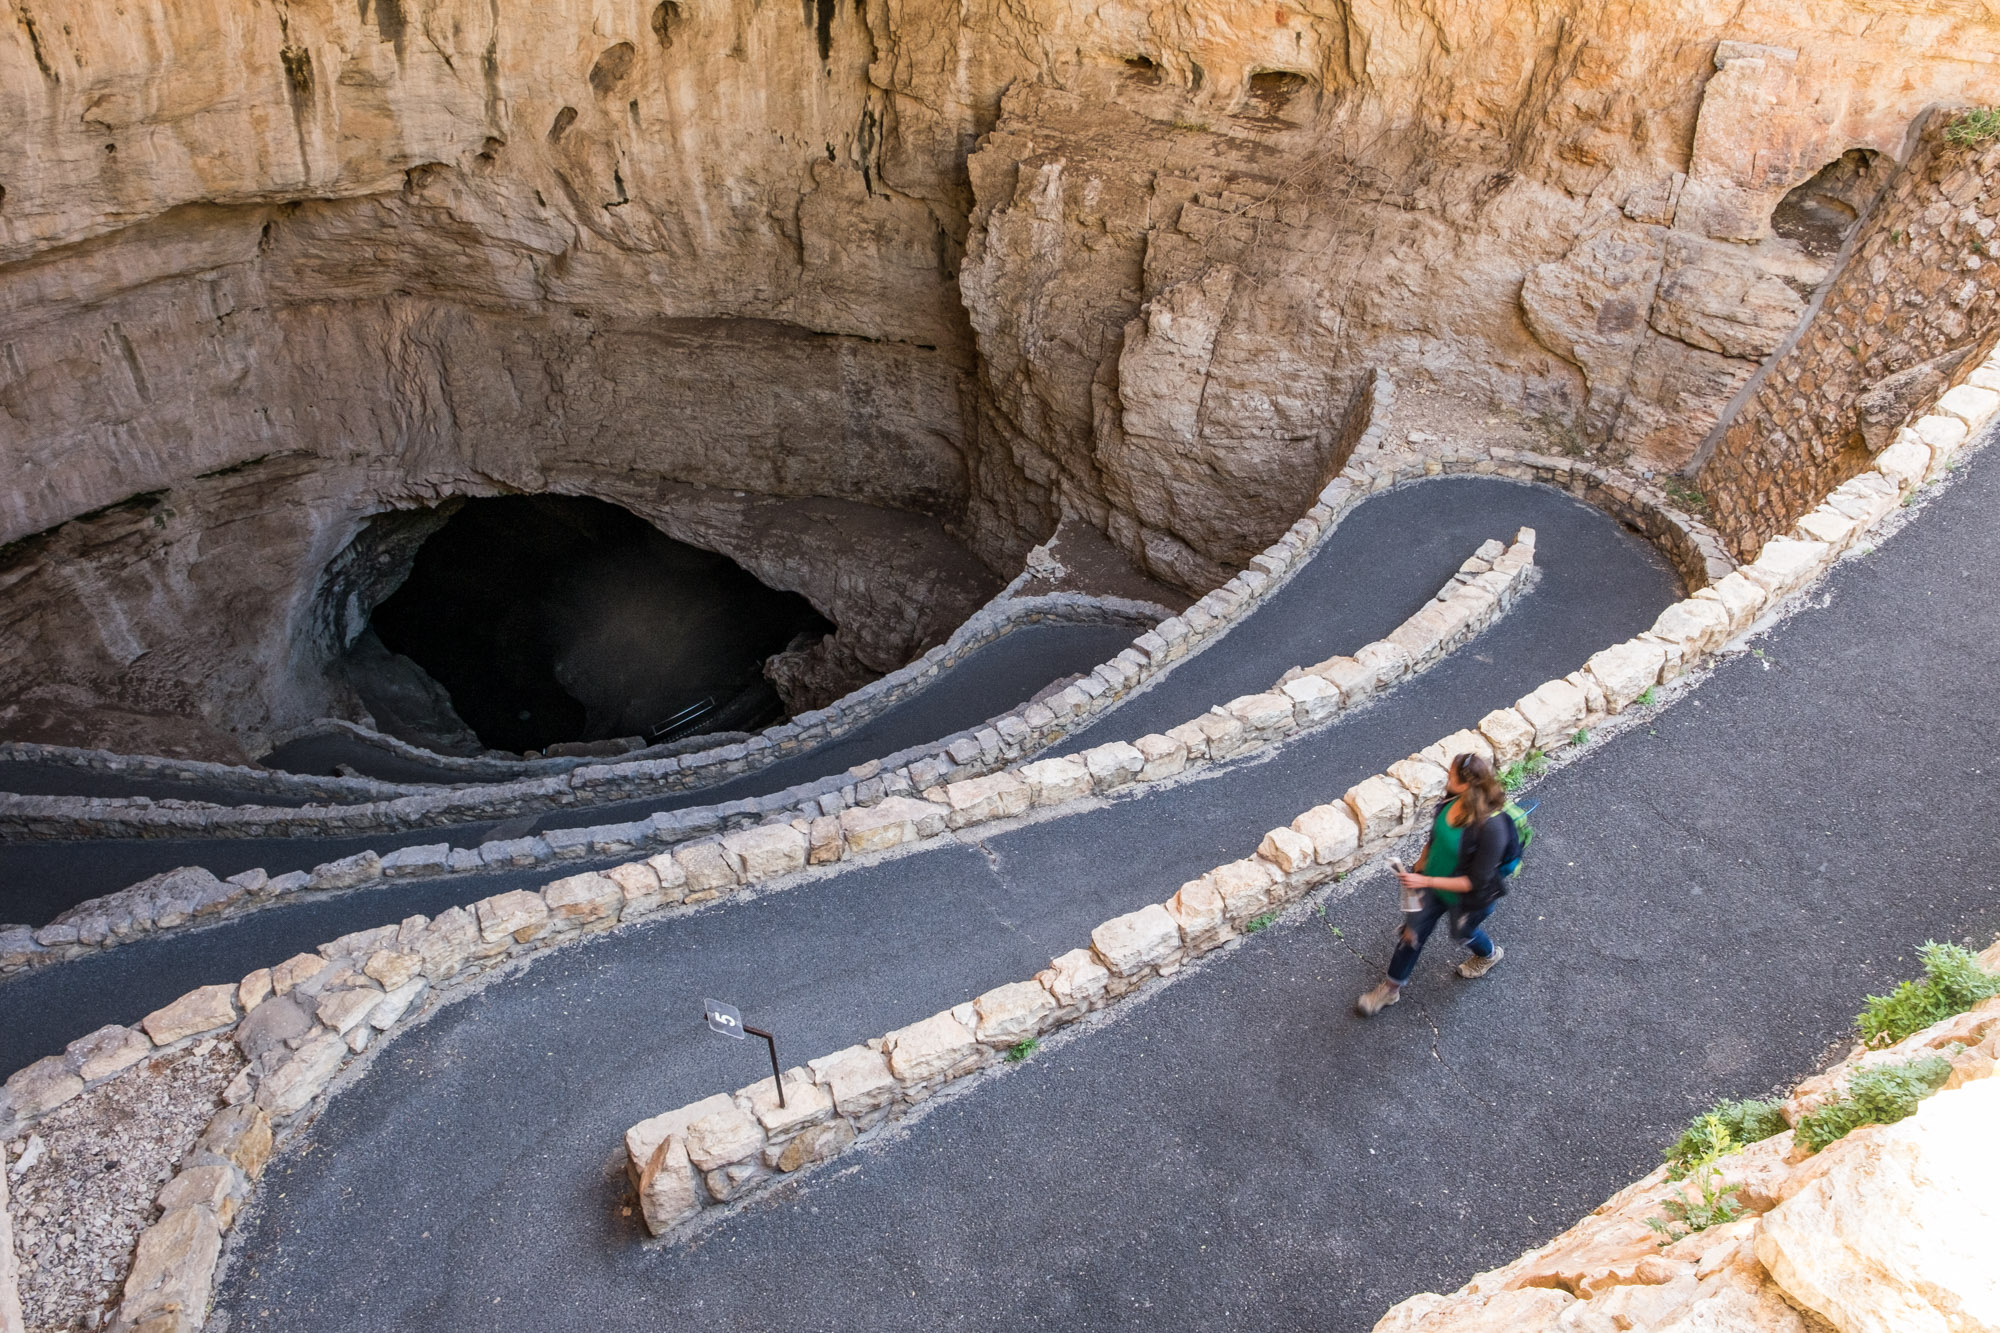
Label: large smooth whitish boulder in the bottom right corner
xmin=1756 ymin=1079 xmax=2000 ymax=1333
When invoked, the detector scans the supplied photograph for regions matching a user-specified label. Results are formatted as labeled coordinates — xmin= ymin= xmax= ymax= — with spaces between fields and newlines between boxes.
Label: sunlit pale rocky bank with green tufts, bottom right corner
xmin=1376 ymin=943 xmax=2000 ymax=1333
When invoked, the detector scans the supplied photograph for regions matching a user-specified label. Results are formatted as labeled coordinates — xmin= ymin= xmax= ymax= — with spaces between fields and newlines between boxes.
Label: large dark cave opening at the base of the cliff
xmin=348 ymin=496 xmax=834 ymax=753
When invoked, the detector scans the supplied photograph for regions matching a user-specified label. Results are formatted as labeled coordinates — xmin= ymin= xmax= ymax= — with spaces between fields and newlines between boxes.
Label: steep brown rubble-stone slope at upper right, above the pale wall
xmin=1698 ymin=110 xmax=2000 ymax=552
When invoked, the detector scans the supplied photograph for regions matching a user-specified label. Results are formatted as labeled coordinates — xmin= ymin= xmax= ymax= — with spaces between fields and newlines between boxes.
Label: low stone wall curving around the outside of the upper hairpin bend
xmin=0 ymin=438 xmax=1734 ymax=975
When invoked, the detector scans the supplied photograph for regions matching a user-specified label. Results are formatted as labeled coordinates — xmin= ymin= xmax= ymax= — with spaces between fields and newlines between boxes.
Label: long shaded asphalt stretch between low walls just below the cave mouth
xmin=0 ymin=622 xmax=1134 ymax=925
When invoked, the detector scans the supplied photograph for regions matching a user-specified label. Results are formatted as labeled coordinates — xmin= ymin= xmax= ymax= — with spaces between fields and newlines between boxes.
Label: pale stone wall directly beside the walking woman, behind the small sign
xmin=608 ymin=366 xmax=2000 ymax=1235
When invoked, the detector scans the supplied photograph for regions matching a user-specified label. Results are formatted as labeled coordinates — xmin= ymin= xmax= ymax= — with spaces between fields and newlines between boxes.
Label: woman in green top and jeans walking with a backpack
xmin=1354 ymin=755 xmax=1518 ymax=1019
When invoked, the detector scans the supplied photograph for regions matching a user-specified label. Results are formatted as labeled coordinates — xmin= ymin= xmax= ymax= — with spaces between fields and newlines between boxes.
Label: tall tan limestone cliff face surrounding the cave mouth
xmin=0 ymin=0 xmax=2000 ymax=745
